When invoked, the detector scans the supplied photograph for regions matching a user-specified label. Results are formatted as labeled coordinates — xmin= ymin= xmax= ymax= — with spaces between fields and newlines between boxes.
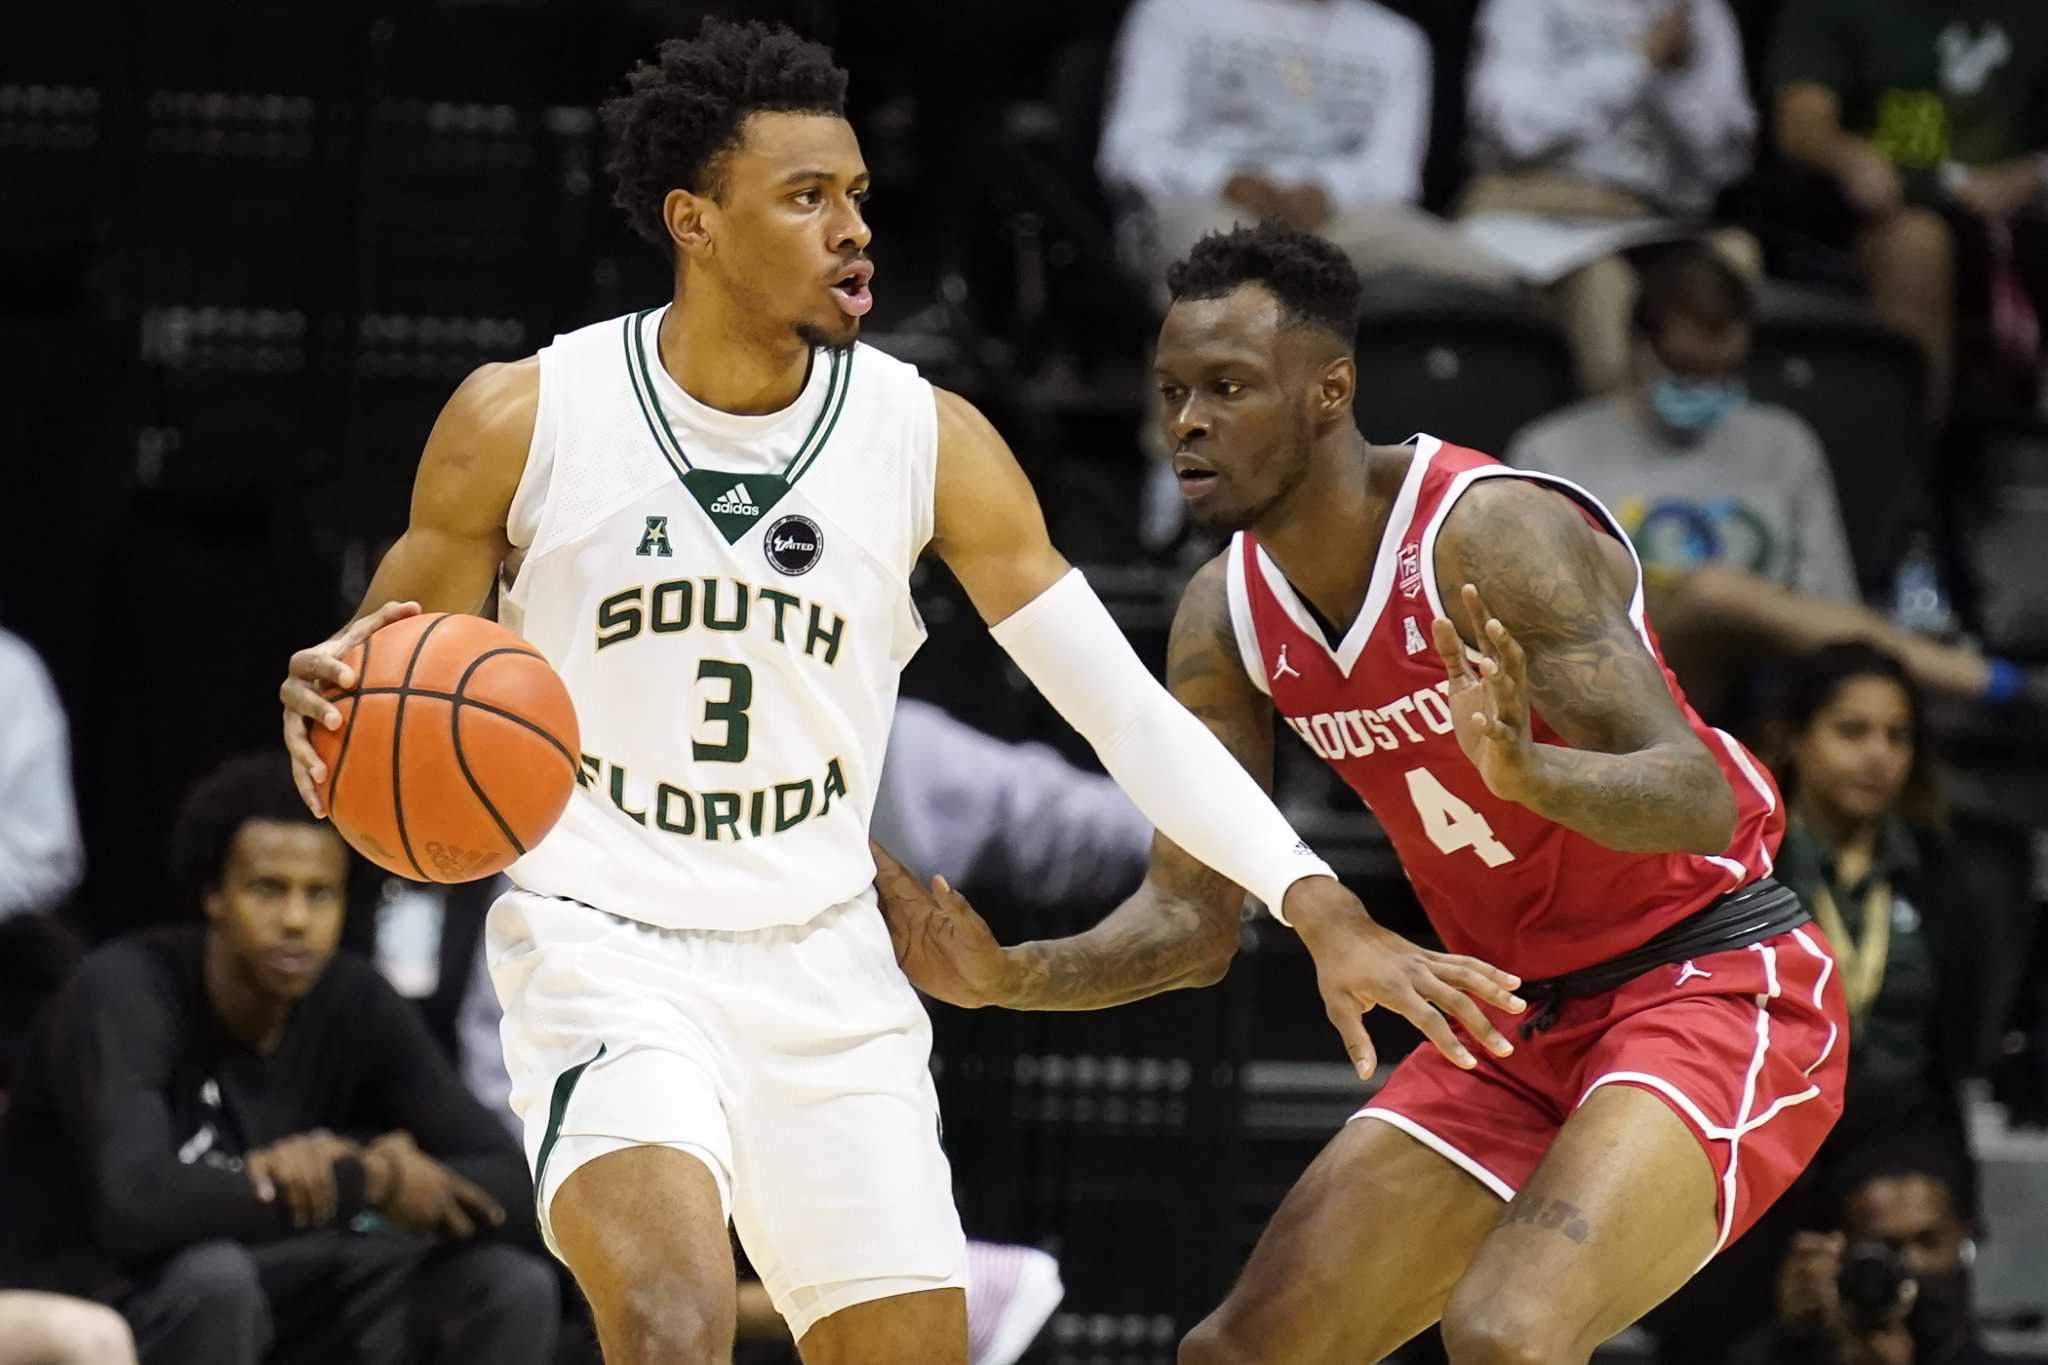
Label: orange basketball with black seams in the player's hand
xmin=311 ymin=612 xmax=580 ymax=882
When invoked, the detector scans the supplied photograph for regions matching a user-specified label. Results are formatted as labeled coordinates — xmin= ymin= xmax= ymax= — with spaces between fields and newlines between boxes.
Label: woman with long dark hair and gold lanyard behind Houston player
xmin=1772 ymin=643 xmax=1970 ymax=1152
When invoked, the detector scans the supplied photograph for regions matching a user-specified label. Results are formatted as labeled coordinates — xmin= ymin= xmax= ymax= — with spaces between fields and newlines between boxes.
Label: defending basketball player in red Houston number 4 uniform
xmin=885 ymin=225 xmax=1847 ymax=1365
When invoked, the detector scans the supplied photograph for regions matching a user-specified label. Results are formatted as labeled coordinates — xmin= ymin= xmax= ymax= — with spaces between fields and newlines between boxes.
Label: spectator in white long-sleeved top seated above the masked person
xmin=1460 ymin=0 xmax=1761 ymax=393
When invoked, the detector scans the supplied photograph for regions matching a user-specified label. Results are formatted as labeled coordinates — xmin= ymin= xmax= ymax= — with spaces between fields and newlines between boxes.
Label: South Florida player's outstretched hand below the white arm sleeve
xmin=1282 ymin=876 xmax=1524 ymax=1081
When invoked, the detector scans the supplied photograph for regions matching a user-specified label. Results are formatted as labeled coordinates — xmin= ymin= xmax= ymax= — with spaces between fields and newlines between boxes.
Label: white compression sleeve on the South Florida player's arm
xmin=989 ymin=569 xmax=1335 ymax=923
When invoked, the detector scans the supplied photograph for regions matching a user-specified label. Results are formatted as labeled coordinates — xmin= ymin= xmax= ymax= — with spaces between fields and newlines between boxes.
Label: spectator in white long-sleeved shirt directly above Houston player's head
xmin=1098 ymin=0 xmax=1513 ymax=289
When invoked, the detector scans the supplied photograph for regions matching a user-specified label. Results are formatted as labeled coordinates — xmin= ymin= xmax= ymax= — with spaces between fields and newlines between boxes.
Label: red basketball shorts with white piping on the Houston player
xmin=1354 ymin=925 xmax=1849 ymax=1252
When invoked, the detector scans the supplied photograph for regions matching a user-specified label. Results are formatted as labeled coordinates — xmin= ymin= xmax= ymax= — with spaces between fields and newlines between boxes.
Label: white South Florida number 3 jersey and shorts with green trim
xmin=489 ymin=309 xmax=965 ymax=1336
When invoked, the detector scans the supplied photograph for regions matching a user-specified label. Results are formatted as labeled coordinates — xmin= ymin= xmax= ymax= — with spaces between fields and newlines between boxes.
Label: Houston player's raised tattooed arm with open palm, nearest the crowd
xmin=1436 ymin=479 xmax=1735 ymax=853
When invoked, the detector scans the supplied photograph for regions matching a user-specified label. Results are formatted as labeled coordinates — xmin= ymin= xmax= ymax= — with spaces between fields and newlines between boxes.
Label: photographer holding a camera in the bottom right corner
xmin=1729 ymin=1142 xmax=1995 ymax=1365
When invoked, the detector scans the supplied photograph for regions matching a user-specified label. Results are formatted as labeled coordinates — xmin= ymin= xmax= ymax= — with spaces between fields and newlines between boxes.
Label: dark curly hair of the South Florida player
xmin=598 ymin=18 xmax=846 ymax=246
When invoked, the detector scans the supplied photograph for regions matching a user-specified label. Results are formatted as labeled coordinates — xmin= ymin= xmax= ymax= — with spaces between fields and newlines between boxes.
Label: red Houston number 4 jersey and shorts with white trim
xmin=1227 ymin=436 xmax=1847 ymax=1244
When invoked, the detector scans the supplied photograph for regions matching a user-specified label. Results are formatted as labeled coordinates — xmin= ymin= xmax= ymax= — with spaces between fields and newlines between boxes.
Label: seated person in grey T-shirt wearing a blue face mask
xmin=1507 ymin=244 xmax=1855 ymax=600
